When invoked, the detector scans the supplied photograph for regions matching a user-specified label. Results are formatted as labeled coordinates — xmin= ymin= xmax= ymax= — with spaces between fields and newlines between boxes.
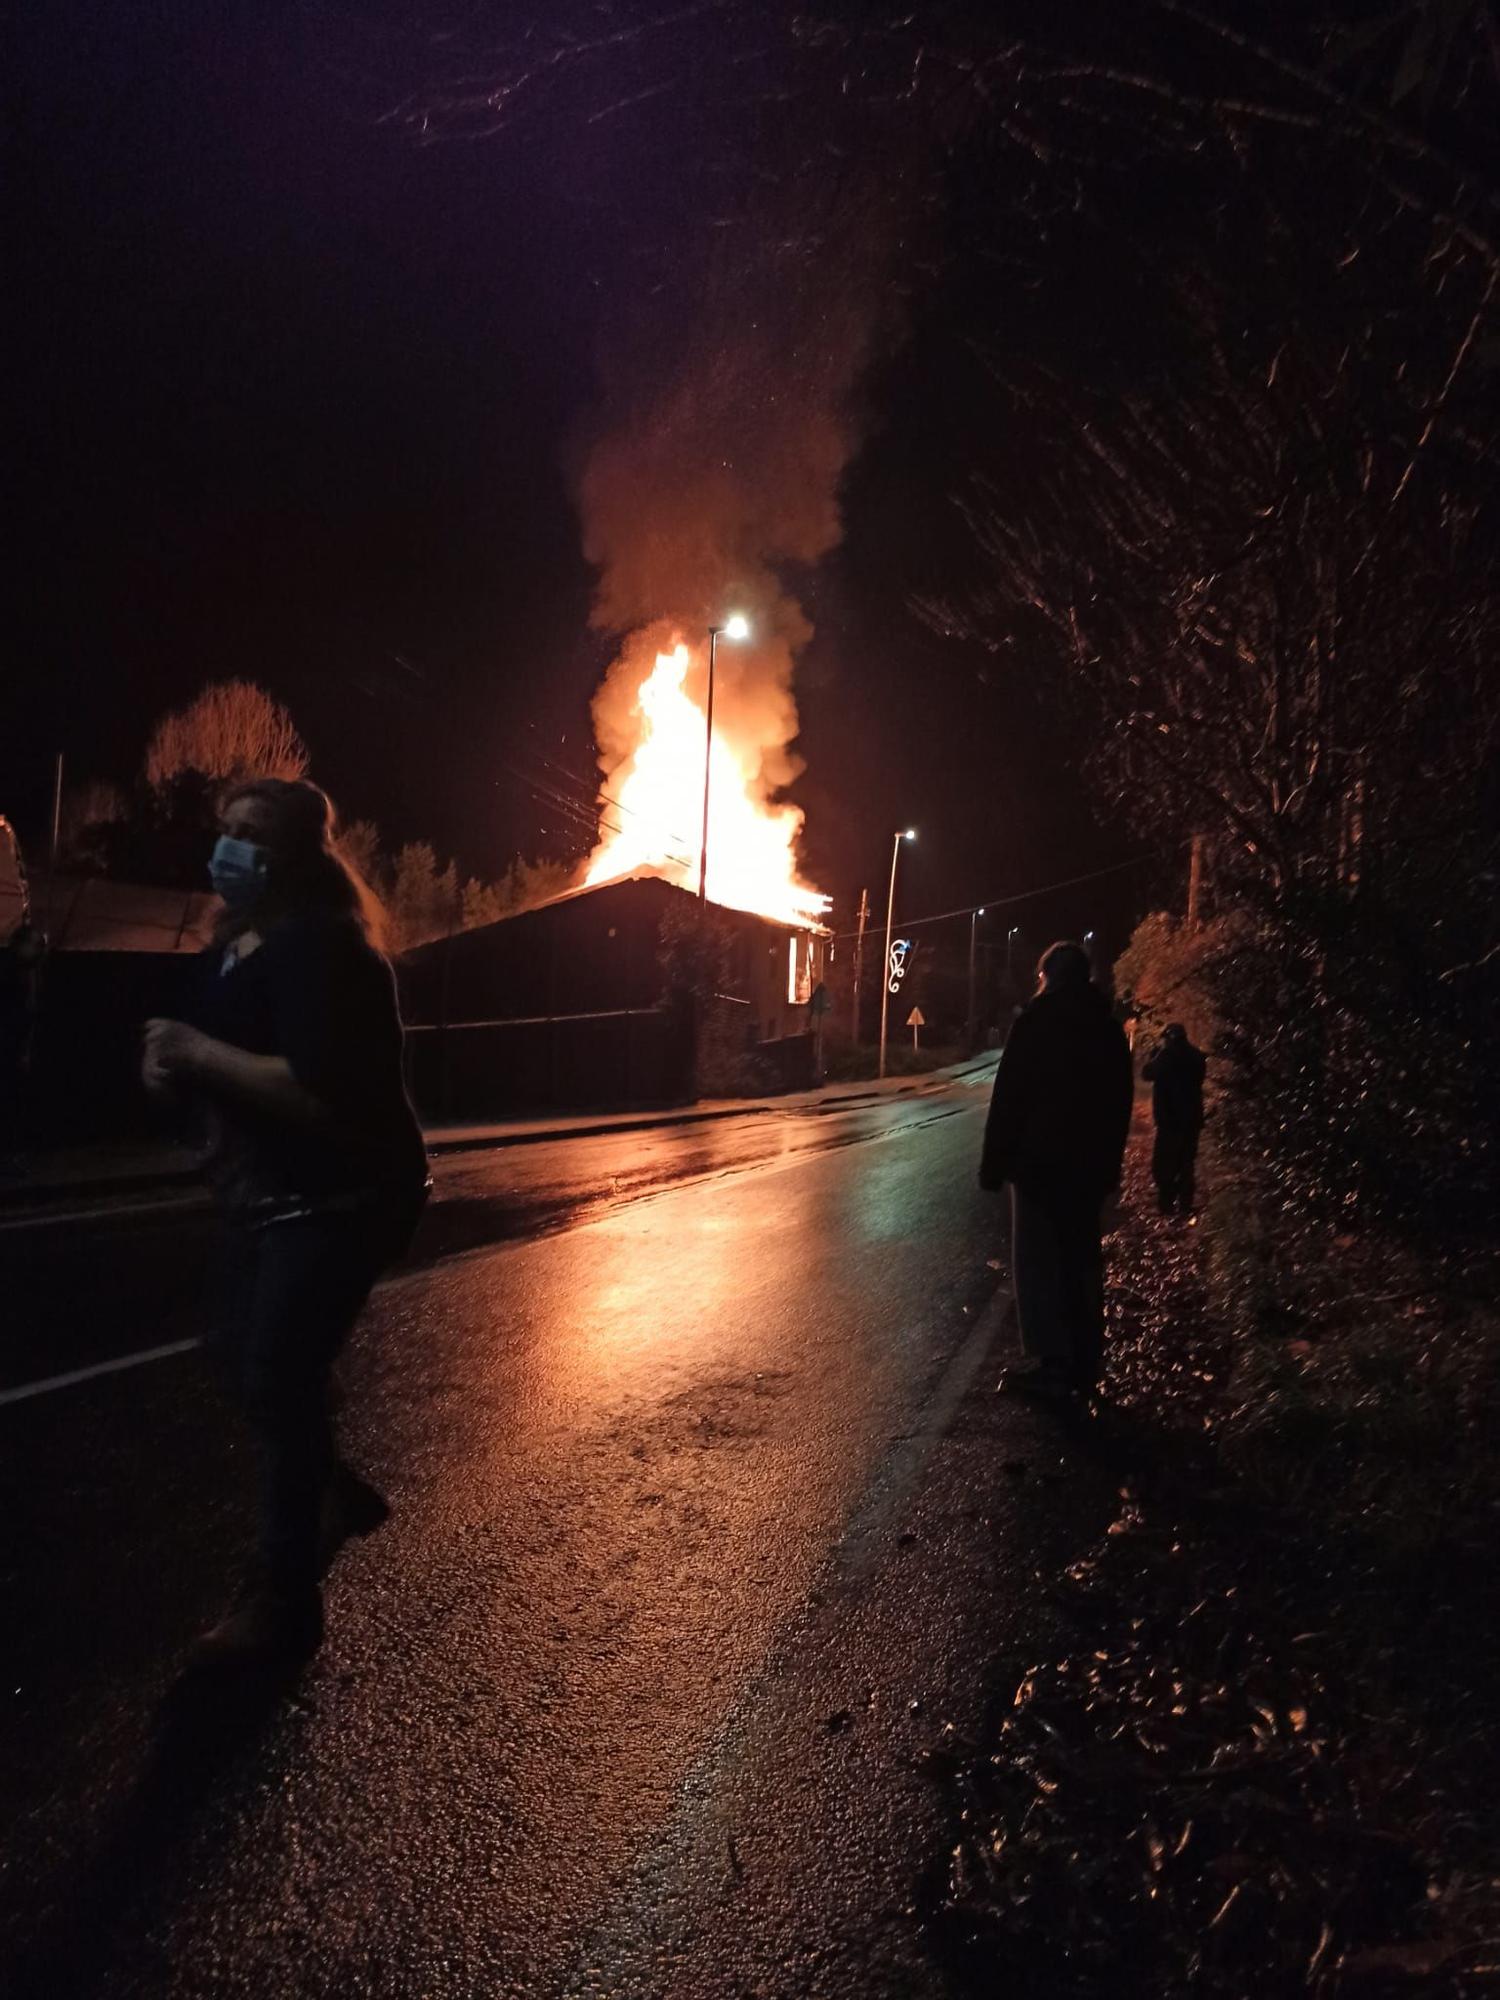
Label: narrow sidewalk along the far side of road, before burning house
xmin=0 ymin=1052 xmax=996 ymax=1222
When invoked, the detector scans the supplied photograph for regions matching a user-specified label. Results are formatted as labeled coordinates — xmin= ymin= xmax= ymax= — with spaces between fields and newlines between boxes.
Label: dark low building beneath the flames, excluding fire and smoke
xmin=400 ymin=876 xmax=824 ymax=1120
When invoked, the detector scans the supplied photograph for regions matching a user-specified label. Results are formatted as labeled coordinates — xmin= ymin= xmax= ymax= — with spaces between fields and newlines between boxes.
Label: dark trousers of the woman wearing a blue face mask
xmin=218 ymin=1208 xmax=416 ymax=1598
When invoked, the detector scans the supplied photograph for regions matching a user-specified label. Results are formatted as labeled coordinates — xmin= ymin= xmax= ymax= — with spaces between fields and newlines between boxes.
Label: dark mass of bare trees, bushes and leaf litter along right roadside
xmin=876 ymin=11 xmax=1500 ymax=1996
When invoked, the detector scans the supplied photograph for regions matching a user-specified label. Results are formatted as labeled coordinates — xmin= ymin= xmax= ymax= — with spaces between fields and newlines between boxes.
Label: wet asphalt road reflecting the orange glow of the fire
xmin=0 ymin=1078 xmax=1112 ymax=2000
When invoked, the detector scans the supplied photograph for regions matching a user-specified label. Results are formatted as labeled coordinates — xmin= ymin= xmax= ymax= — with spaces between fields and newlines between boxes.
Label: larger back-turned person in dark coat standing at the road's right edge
xmin=980 ymin=942 xmax=1134 ymax=1396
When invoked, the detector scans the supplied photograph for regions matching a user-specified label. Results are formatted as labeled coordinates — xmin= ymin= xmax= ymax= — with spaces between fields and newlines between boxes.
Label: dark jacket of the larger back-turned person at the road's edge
xmin=980 ymin=986 xmax=1134 ymax=1202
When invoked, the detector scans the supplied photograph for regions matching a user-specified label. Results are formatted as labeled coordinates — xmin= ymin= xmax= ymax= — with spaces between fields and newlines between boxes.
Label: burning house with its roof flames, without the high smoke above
xmin=402 ymin=620 xmax=828 ymax=1118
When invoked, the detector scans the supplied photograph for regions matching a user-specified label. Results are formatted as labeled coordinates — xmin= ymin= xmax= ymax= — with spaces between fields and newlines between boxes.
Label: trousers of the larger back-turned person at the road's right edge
xmin=1010 ymin=1186 xmax=1104 ymax=1388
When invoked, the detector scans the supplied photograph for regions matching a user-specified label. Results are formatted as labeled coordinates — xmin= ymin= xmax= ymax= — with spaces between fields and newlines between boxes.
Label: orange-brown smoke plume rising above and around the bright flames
xmin=580 ymin=203 xmax=876 ymax=892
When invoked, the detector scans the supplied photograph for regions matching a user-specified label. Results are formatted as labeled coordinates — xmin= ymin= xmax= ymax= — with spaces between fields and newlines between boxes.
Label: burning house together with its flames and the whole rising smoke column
xmin=402 ymin=232 xmax=880 ymax=1116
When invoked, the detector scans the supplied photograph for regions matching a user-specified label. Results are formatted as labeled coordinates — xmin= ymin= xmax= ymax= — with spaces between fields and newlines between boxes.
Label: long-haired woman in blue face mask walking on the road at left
xmin=144 ymin=778 xmax=428 ymax=1666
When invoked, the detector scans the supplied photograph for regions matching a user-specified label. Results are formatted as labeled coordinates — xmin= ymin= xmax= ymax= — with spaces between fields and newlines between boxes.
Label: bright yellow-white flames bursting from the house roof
xmin=584 ymin=644 xmax=828 ymax=924
